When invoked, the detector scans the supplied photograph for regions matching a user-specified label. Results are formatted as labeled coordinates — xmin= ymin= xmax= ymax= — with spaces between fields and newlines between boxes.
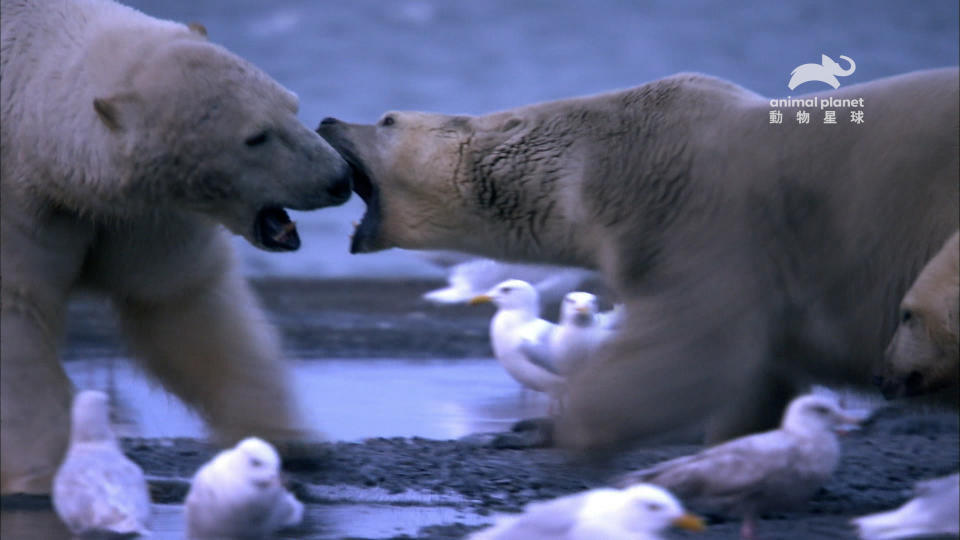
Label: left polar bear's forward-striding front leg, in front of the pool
xmin=115 ymin=266 xmax=300 ymax=443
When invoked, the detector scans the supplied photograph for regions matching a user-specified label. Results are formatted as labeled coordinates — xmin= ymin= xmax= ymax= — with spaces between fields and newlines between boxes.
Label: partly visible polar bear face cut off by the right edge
xmin=880 ymin=232 xmax=960 ymax=403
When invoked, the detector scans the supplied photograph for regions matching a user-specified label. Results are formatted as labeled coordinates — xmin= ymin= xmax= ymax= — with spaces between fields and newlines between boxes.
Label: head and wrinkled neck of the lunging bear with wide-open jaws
xmin=317 ymin=105 xmax=588 ymax=258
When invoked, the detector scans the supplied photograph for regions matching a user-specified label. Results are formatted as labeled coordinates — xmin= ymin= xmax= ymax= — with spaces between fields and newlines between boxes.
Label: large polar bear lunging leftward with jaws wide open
xmin=318 ymin=69 xmax=960 ymax=447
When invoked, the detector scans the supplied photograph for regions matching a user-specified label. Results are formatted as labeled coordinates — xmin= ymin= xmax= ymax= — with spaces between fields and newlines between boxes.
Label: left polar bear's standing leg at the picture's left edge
xmin=0 ymin=206 xmax=94 ymax=494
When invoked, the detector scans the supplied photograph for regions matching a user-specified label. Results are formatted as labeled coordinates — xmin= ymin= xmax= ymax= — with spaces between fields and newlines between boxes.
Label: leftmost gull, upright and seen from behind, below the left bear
xmin=53 ymin=390 xmax=150 ymax=537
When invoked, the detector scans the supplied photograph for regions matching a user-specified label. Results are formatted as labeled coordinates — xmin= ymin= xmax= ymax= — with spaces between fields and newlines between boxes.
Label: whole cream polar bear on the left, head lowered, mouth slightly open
xmin=0 ymin=0 xmax=350 ymax=493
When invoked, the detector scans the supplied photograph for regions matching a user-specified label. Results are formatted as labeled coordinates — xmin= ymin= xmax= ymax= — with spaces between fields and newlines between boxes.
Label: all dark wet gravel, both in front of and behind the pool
xmin=28 ymin=280 xmax=960 ymax=540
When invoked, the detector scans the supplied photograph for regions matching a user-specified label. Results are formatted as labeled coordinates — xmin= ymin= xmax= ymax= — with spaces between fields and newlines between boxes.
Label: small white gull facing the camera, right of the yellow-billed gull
xmin=547 ymin=291 xmax=613 ymax=376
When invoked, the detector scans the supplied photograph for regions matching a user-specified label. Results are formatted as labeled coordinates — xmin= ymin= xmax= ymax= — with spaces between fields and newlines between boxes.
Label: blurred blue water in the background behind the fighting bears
xmin=125 ymin=0 xmax=960 ymax=277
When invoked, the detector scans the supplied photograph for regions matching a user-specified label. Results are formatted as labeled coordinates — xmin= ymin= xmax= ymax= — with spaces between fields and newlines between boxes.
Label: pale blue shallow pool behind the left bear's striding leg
xmin=65 ymin=358 xmax=548 ymax=441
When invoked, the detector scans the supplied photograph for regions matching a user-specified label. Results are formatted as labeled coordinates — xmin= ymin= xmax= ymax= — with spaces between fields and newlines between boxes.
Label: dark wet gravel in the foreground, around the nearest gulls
xmin=124 ymin=408 xmax=960 ymax=540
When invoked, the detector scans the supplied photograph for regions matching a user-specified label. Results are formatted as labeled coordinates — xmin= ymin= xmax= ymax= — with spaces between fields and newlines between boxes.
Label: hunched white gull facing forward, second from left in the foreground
xmin=186 ymin=437 xmax=303 ymax=540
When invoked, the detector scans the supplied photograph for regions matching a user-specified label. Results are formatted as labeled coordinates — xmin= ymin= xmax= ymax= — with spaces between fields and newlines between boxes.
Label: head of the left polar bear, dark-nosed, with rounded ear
xmin=93 ymin=34 xmax=350 ymax=251
